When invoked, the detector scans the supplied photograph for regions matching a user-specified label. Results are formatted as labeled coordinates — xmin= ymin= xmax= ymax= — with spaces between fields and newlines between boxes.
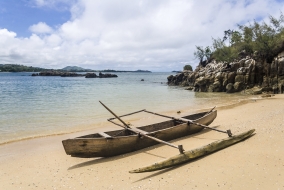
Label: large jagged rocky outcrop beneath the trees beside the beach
xmin=168 ymin=52 xmax=284 ymax=94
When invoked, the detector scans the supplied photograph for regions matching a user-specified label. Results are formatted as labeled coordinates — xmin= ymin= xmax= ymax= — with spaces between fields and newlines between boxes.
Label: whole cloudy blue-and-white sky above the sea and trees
xmin=0 ymin=0 xmax=284 ymax=72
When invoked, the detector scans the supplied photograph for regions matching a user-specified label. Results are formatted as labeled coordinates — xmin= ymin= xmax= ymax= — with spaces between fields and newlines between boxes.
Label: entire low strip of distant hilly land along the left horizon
xmin=0 ymin=64 xmax=151 ymax=73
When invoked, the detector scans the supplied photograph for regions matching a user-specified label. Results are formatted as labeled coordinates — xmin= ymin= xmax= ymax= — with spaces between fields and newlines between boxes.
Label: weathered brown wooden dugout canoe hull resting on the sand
xmin=62 ymin=110 xmax=217 ymax=158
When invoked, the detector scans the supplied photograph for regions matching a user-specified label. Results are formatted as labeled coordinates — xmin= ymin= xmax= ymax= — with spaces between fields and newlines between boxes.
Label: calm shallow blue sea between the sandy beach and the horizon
xmin=0 ymin=73 xmax=253 ymax=144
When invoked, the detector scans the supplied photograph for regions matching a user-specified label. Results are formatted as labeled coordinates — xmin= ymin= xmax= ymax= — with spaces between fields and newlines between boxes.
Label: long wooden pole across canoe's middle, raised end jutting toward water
xmin=99 ymin=101 xmax=184 ymax=154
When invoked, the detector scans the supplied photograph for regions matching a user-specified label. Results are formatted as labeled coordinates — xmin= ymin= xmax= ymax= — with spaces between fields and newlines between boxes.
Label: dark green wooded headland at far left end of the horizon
xmin=0 ymin=64 xmax=46 ymax=72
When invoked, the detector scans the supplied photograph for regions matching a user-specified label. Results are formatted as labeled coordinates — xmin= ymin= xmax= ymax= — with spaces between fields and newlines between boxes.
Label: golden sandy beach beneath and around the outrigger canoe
xmin=0 ymin=95 xmax=284 ymax=189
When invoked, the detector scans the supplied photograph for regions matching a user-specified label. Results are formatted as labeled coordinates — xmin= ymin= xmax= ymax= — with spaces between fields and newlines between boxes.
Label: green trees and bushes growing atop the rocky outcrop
xmin=194 ymin=13 xmax=284 ymax=63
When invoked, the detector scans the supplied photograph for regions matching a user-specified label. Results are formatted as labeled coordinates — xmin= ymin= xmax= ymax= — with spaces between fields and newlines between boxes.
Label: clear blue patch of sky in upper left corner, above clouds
xmin=0 ymin=0 xmax=71 ymax=37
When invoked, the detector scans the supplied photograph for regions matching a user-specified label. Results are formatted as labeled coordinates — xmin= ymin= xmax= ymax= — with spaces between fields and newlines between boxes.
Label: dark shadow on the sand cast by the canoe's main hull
xmin=67 ymin=125 xmax=219 ymax=170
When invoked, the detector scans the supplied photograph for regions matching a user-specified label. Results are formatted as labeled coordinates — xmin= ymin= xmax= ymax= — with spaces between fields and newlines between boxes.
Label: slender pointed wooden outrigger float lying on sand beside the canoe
xmin=129 ymin=129 xmax=255 ymax=173
